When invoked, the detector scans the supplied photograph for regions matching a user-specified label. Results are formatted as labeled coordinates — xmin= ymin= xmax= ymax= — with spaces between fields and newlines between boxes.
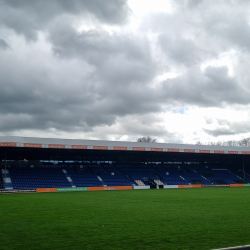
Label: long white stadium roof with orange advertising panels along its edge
xmin=0 ymin=136 xmax=250 ymax=155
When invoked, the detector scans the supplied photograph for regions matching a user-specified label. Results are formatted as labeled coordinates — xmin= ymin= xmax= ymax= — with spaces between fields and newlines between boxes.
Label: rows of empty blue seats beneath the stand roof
xmin=0 ymin=165 xmax=250 ymax=188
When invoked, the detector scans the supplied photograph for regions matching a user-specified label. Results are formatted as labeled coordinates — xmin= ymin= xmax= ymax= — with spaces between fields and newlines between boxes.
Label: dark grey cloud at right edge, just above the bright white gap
xmin=159 ymin=67 xmax=249 ymax=106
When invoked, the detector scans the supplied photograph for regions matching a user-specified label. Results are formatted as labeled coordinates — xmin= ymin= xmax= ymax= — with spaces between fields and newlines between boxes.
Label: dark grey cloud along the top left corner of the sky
xmin=0 ymin=0 xmax=130 ymax=40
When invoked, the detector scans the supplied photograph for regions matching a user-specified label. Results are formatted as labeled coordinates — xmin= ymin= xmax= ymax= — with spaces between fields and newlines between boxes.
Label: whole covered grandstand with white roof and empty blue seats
xmin=0 ymin=136 xmax=250 ymax=189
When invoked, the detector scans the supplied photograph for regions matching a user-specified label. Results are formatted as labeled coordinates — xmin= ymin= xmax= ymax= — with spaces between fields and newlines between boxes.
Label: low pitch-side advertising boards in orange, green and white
xmin=0 ymin=184 xmax=250 ymax=194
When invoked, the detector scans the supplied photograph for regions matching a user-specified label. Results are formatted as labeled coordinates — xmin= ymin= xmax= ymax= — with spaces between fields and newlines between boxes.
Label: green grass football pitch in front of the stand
xmin=0 ymin=188 xmax=250 ymax=250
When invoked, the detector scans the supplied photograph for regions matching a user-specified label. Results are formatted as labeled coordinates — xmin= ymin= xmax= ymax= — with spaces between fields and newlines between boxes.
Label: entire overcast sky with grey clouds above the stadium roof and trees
xmin=0 ymin=0 xmax=250 ymax=143
